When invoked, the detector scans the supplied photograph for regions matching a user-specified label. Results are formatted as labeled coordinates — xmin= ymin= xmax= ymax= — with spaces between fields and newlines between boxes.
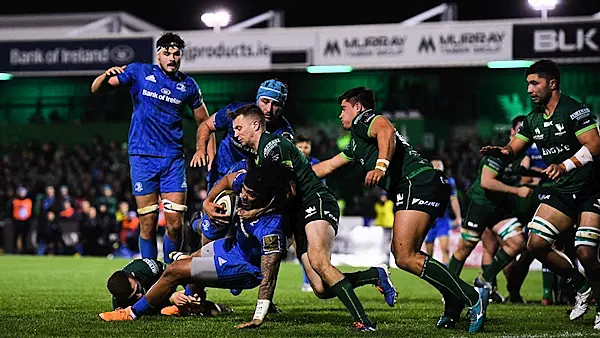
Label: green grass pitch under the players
xmin=0 ymin=256 xmax=600 ymax=338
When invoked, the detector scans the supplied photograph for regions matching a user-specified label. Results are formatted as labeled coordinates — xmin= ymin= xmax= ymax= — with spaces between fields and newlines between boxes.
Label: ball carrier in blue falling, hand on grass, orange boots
xmin=100 ymin=164 xmax=293 ymax=328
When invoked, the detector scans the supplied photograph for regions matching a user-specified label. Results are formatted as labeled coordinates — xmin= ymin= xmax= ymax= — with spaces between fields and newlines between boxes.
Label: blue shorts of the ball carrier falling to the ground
xmin=207 ymin=238 xmax=262 ymax=289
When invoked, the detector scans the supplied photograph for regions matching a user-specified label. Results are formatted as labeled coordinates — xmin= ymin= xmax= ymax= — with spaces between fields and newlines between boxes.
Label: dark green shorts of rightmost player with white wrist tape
xmin=542 ymin=187 xmax=600 ymax=222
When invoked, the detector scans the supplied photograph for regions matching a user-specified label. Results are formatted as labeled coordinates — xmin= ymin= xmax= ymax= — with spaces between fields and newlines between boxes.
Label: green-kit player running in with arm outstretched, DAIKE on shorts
xmin=309 ymin=87 xmax=488 ymax=332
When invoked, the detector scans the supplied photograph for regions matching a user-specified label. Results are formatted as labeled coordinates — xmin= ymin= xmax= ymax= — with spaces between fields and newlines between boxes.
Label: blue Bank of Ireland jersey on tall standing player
xmin=117 ymin=63 xmax=203 ymax=157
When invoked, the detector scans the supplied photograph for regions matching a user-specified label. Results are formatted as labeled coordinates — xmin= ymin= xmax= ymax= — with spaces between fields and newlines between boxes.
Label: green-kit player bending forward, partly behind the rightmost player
xmin=448 ymin=117 xmax=532 ymax=291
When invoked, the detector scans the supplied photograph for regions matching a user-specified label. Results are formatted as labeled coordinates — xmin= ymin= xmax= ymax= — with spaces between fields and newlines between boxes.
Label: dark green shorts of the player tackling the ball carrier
xmin=290 ymin=193 xmax=340 ymax=259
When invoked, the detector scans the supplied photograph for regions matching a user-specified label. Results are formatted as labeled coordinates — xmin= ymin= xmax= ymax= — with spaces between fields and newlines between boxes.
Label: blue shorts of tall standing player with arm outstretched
xmin=129 ymin=155 xmax=187 ymax=196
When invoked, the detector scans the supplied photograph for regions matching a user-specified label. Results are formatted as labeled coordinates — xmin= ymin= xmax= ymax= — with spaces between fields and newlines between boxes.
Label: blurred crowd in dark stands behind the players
xmin=0 ymin=132 xmax=488 ymax=257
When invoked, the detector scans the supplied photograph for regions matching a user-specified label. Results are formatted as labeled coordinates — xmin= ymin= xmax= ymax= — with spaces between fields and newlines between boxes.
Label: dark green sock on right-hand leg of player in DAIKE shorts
xmin=419 ymin=256 xmax=479 ymax=307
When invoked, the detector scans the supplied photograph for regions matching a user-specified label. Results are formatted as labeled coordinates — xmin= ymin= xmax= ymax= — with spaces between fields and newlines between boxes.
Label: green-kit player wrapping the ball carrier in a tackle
xmin=228 ymin=105 xmax=396 ymax=332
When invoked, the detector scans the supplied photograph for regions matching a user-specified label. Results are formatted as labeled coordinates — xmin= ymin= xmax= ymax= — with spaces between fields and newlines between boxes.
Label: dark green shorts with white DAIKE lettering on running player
xmin=388 ymin=169 xmax=450 ymax=221
